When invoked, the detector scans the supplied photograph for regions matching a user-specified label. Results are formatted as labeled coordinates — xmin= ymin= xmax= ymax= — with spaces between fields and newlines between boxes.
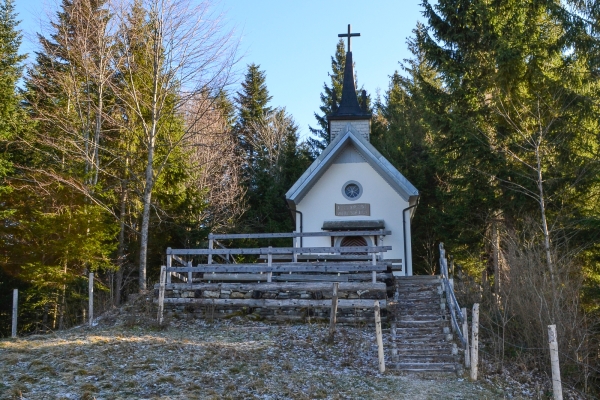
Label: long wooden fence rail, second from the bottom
xmin=154 ymin=282 xmax=387 ymax=292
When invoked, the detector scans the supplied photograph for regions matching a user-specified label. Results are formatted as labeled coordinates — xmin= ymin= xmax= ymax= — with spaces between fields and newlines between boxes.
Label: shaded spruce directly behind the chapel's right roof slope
xmin=371 ymin=28 xmax=444 ymax=274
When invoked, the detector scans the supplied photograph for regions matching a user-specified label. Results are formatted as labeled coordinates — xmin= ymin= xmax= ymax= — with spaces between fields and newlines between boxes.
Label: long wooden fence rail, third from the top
xmin=167 ymin=262 xmax=388 ymax=273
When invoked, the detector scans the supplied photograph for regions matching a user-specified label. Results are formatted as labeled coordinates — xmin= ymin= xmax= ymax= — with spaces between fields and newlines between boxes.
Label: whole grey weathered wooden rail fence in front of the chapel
xmin=157 ymin=230 xmax=397 ymax=321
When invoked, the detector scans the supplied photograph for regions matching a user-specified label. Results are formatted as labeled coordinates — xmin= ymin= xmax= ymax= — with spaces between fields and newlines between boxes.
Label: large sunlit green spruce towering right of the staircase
xmin=416 ymin=0 xmax=597 ymax=272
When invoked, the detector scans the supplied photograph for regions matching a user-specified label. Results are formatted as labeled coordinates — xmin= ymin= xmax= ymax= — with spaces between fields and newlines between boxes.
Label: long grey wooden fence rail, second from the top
xmin=167 ymin=246 xmax=392 ymax=255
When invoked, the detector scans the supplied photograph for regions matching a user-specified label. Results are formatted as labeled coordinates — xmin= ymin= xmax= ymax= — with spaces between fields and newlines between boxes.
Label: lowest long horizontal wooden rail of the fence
xmin=155 ymin=297 xmax=386 ymax=308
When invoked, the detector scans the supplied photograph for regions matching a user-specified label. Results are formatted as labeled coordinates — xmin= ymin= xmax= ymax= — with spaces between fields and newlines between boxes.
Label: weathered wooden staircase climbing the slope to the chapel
xmin=388 ymin=276 xmax=462 ymax=373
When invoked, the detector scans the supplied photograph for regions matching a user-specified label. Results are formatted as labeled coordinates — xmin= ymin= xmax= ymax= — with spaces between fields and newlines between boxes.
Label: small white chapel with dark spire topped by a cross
xmin=286 ymin=26 xmax=419 ymax=276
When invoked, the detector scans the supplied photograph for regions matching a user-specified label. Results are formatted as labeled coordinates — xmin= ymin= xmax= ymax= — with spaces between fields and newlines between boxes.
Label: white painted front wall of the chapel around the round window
xmin=296 ymin=150 xmax=412 ymax=275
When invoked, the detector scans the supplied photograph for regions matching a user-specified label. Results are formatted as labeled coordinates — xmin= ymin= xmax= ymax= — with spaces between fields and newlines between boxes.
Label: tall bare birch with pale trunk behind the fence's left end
xmin=114 ymin=0 xmax=236 ymax=290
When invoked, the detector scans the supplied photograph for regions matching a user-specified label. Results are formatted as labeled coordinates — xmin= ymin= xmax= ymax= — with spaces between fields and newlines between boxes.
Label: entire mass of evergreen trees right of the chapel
xmin=372 ymin=0 xmax=600 ymax=392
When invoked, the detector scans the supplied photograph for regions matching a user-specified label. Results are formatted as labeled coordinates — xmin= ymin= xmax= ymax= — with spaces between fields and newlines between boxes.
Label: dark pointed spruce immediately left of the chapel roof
xmin=235 ymin=64 xmax=310 ymax=236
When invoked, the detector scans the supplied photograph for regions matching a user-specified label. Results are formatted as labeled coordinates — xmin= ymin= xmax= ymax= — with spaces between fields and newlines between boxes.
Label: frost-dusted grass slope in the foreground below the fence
xmin=0 ymin=296 xmax=504 ymax=399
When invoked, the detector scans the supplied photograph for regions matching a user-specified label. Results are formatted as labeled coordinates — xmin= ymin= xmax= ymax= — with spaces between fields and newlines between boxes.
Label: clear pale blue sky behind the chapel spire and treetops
xmin=15 ymin=0 xmax=423 ymax=141
